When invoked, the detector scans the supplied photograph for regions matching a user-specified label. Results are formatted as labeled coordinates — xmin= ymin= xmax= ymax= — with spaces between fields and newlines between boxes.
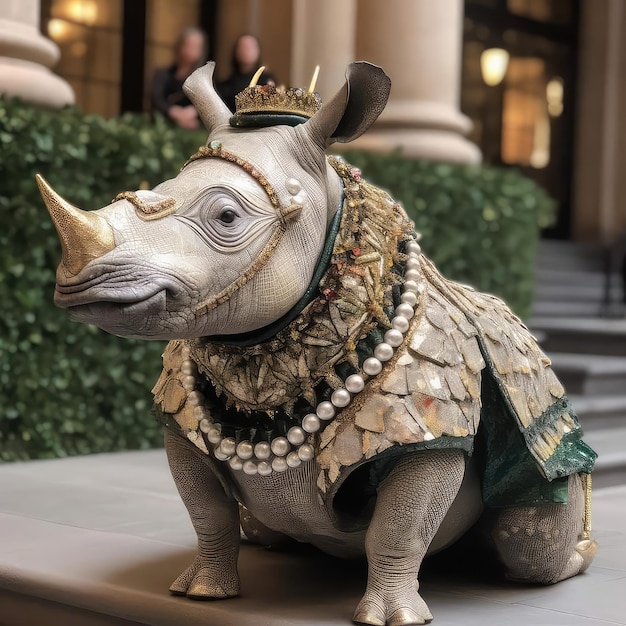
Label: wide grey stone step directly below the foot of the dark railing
xmin=527 ymin=315 xmax=626 ymax=356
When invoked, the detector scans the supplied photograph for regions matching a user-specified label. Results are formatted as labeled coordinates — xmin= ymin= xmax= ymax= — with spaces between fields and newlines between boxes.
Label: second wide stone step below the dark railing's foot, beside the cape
xmin=549 ymin=352 xmax=626 ymax=398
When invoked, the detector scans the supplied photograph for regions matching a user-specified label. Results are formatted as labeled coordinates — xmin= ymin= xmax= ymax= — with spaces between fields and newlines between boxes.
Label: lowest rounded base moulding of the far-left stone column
xmin=0 ymin=57 xmax=74 ymax=108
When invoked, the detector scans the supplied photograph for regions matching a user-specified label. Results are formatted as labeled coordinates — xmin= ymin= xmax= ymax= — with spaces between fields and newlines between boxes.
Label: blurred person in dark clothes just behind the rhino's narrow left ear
xmin=151 ymin=27 xmax=208 ymax=129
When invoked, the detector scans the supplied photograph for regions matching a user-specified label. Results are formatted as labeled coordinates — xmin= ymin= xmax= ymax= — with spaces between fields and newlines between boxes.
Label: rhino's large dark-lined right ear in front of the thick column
xmin=304 ymin=61 xmax=391 ymax=148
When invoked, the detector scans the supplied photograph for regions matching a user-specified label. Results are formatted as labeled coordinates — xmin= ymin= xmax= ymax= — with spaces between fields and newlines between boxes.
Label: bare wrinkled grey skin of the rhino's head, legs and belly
xmin=40 ymin=63 xmax=592 ymax=626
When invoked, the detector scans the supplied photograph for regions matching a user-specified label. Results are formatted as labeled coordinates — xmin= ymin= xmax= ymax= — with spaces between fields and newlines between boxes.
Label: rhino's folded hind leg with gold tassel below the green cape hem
xmin=491 ymin=475 xmax=597 ymax=585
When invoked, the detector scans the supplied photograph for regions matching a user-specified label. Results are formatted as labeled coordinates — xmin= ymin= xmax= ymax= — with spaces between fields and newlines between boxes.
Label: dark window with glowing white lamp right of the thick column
xmin=461 ymin=0 xmax=578 ymax=237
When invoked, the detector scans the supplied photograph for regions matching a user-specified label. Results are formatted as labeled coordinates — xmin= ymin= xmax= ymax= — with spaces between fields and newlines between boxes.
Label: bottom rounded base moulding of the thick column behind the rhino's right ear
xmin=344 ymin=127 xmax=482 ymax=164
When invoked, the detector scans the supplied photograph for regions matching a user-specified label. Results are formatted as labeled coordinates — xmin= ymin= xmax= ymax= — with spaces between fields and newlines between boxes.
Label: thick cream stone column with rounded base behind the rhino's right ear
xmin=352 ymin=0 xmax=481 ymax=163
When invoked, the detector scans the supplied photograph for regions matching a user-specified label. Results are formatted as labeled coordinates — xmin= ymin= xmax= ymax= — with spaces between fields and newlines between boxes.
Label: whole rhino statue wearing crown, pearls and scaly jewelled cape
xmin=38 ymin=63 xmax=597 ymax=626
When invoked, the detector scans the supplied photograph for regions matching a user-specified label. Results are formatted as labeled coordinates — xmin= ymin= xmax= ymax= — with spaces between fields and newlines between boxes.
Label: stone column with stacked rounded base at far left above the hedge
xmin=0 ymin=0 xmax=74 ymax=107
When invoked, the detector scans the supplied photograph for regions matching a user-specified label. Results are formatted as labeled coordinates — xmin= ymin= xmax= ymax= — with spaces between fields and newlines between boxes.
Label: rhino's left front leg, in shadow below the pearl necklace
xmin=165 ymin=429 xmax=240 ymax=600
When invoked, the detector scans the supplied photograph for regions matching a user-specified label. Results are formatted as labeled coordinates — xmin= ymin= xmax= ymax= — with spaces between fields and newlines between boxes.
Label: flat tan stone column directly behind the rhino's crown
xmin=291 ymin=0 xmax=356 ymax=102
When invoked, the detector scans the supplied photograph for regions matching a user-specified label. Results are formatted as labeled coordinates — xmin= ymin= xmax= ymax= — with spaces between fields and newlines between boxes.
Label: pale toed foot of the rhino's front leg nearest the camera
xmin=352 ymin=582 xmax=433 ymax=626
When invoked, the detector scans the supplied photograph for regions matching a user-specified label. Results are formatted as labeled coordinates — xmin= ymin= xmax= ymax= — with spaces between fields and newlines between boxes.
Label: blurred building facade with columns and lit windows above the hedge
xmin=0 ymin=0 xmax=626 ymax=243
